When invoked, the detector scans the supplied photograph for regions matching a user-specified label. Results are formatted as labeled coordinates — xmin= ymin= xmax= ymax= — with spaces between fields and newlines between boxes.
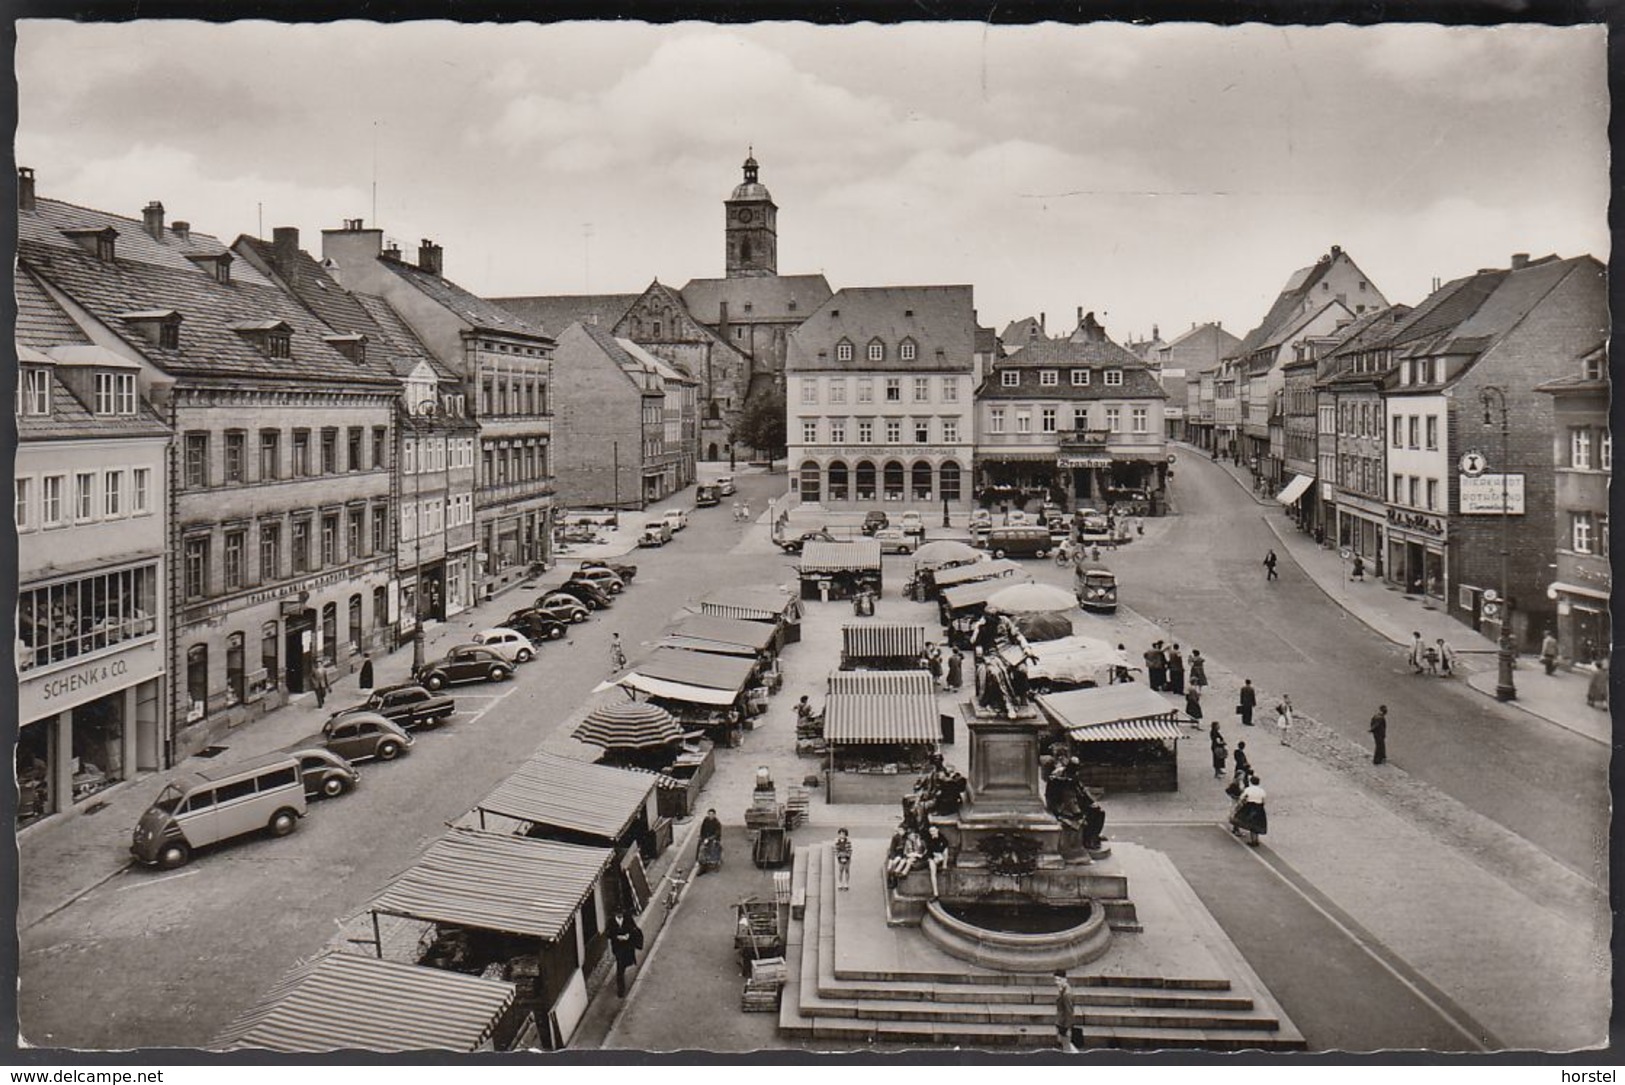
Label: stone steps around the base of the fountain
xmin=778 ymin=846 xmax=1303 ymax=1051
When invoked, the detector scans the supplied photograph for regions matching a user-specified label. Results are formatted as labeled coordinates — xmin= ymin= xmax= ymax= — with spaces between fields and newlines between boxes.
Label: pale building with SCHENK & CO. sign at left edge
xmin=15 ymin=259 xmax=169 ymax=827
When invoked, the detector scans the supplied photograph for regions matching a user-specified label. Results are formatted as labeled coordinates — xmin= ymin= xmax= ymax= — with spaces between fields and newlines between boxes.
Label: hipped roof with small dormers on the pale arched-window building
xmin=785 ymin=286 xmax=977 ymax=372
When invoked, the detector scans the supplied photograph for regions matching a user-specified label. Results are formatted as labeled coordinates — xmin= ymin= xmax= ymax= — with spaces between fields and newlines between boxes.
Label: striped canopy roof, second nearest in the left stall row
xmin=371 ymin=828 xmax=614 ymax=942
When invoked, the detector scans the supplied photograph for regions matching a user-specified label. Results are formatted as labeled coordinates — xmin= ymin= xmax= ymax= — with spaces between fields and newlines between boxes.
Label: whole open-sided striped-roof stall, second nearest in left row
xmin=369 ymin=828 xmax=617 ymax=1049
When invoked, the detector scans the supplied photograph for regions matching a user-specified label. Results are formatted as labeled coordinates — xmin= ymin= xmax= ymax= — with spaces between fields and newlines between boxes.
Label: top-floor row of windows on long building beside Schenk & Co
xmin=180 ymin=426 xmax=388 ymax=489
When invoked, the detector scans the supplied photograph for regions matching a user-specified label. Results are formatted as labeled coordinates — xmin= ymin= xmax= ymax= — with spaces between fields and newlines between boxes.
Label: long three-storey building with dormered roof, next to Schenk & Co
xmin=18 ymin=175 xmax=397 ymax=765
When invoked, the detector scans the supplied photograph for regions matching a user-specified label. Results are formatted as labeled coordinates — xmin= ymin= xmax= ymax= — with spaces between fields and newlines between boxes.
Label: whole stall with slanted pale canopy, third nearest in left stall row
xmin=475 ymin=752 xmax=671 ymax=861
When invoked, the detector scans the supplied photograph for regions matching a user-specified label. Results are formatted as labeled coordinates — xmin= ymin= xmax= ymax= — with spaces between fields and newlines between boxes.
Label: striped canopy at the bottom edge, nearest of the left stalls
xmin=210 ymin=950 xmax=517 ymax=1054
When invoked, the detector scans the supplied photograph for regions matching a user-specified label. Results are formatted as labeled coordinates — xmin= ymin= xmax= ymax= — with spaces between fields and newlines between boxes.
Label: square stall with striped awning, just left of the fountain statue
xmin=824 ymin=671 xmax=943 ymax=804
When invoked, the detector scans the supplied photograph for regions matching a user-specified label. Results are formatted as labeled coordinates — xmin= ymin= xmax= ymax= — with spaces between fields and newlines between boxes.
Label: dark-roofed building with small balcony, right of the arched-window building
xmin=977 ymin=313 xmax=1168 ymax=513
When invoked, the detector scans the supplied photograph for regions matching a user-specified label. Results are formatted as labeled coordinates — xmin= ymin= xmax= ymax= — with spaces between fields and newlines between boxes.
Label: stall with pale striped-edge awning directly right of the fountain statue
xmin=1037 ymin=682 xmax=1191 ymax=791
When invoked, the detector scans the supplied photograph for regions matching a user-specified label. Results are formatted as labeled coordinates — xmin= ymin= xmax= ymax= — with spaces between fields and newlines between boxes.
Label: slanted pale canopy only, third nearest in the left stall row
xmin=475 ymin=754 xmax=655 ymax=840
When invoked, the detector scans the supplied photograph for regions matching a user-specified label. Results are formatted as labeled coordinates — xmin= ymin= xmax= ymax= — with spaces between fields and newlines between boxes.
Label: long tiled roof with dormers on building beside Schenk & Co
xmin=18 ymin=200 xmax=395 ymax=383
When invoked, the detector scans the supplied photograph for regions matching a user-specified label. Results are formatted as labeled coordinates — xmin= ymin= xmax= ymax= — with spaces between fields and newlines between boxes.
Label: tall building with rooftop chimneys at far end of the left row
xmin=322 ymin=219 xmax=554 ymax=598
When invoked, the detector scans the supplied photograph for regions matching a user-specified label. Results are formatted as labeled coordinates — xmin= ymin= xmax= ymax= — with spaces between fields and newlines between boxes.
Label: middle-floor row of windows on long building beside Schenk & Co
xmin=180 ymin=504 xmax=390 ymax=603
